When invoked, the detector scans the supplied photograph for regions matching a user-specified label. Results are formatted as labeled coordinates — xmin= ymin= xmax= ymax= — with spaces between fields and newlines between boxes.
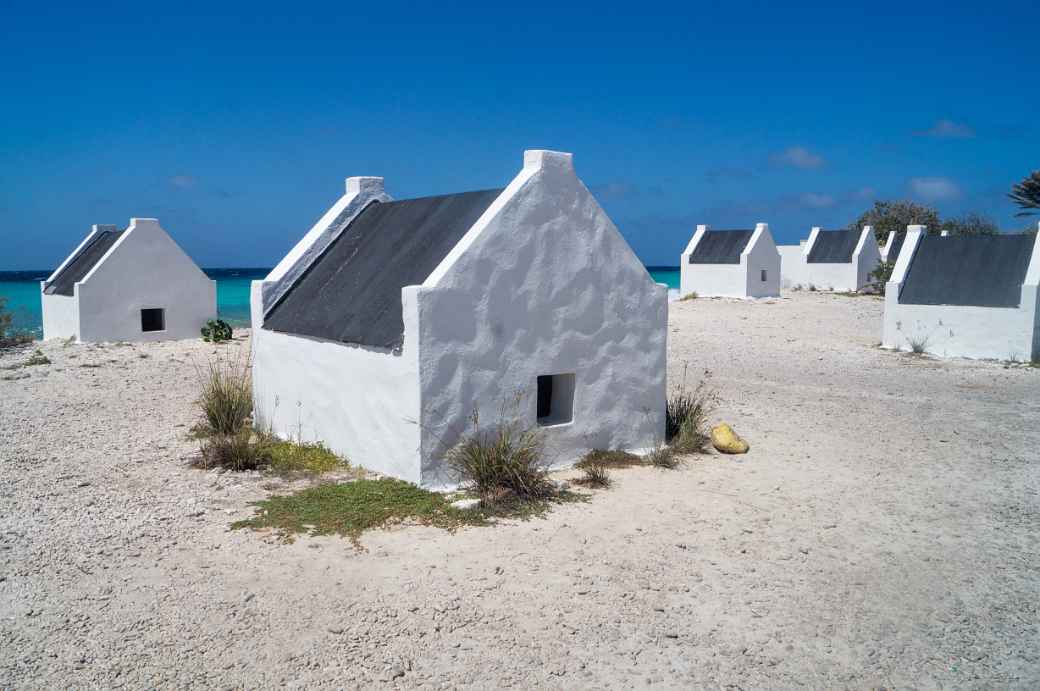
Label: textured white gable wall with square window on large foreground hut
xmin=406 ymin=151 xmax=668 ymax=487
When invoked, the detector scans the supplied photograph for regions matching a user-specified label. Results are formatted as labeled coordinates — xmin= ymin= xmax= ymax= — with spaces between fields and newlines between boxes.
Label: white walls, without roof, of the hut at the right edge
xmin=882 ymin=226 xmax=1040 ymax=360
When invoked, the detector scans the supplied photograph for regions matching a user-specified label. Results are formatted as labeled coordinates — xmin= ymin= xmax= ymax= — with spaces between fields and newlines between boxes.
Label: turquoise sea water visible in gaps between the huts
xmin=0 ymin=266 xmax=679 ymax=337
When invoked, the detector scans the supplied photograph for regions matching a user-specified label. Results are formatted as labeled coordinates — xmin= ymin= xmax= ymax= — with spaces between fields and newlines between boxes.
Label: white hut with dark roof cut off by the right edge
xmin=882 ymin=226 xmax=1040 ymax=361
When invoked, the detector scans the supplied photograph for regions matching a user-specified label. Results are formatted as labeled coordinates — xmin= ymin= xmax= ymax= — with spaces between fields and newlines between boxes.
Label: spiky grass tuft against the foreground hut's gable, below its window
xmin=445 ymin=415 xmax=555 ymax=505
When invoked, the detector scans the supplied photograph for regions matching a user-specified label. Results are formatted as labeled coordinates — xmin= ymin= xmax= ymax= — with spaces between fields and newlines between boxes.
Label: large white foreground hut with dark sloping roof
xmin=252 ymin=151 xmax=668 ymax=488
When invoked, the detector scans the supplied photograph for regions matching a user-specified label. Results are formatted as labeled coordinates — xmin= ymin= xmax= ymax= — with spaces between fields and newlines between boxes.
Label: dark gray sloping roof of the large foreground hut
xmin=263 ymin=189 xmax=501 ymax=349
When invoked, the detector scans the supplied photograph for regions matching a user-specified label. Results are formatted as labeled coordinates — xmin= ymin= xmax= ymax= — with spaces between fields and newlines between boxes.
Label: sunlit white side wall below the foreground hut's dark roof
xmin=251 ymin=281 xmax=419 ymax=483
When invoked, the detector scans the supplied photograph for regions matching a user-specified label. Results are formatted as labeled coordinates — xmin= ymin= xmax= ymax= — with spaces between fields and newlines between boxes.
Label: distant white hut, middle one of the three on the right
xmin=784 ymin=226 xmax=881 ymax=291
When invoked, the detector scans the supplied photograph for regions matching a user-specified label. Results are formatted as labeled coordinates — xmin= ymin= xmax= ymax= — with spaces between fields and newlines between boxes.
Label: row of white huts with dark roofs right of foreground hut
xmin=679 ymin=223 xmax=1040 ymax=360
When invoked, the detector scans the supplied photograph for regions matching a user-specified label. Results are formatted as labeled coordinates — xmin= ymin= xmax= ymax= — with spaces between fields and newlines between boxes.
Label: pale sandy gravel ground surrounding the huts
xmin=0 ymin=293 xmax=1040 ymax=689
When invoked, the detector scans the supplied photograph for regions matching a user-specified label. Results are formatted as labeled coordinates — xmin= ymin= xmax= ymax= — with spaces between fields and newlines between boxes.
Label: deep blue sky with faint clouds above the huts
xmin=0 ymin=2 xmax=1040 ymax=270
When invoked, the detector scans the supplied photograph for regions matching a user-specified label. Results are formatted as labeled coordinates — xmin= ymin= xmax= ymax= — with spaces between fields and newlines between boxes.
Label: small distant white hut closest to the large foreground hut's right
xmin=679 ymin=223 xmax=780 ymax=298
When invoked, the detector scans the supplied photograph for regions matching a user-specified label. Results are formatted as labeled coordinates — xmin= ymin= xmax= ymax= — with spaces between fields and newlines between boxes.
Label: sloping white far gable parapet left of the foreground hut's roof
xmin=262 ymin=177 xmax=390 ymax=313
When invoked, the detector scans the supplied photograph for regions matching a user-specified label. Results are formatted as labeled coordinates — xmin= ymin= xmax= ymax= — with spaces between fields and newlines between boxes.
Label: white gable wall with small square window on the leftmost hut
xmin=75 ymin=219 xmax=216 ymax=341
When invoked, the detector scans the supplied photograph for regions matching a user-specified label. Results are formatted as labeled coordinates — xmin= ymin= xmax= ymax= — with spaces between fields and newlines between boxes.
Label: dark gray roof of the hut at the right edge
xmin=900 ymin=235 xmax=1034 ymax=307
